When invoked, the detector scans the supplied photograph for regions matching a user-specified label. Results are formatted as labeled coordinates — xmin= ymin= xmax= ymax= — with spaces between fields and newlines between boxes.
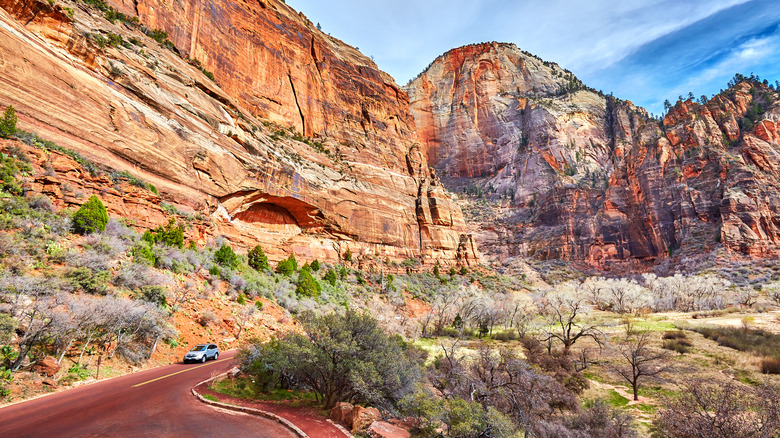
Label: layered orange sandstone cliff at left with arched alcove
xmin=0 ymin=0 xmax=476 ymax=264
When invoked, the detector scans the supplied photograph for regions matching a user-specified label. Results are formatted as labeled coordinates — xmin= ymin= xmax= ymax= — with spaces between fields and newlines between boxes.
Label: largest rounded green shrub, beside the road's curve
xmin=242 ymin=310 xmax=422 ymax=409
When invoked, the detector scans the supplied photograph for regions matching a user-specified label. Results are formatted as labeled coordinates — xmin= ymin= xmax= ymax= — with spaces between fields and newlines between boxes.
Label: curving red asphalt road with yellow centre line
xmin=0 ymin=352 xmax=294 ymax=438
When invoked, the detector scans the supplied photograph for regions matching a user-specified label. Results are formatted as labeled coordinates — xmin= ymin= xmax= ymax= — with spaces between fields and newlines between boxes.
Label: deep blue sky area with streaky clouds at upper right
xmin=583 ymin=0 xmax=780 ymax=113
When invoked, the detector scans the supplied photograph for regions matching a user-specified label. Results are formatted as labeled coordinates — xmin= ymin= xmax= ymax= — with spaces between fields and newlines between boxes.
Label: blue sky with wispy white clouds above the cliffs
xmin=287 ymin=0 xmax=780 ymax=114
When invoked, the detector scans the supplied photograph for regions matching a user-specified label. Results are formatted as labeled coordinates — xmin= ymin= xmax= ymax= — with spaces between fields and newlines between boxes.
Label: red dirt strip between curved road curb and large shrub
xmin=195 ymin=383 xmax=347 ymax=438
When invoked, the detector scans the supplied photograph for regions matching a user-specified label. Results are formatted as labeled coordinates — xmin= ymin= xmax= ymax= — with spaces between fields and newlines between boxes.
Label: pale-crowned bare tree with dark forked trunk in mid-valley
xmin=537 ymin=281 xmax=602 ymax=354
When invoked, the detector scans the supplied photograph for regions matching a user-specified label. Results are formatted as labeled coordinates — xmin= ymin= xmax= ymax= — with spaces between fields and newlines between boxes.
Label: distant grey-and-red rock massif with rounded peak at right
xmin=406 ymin=43 xmax=780 ymax=267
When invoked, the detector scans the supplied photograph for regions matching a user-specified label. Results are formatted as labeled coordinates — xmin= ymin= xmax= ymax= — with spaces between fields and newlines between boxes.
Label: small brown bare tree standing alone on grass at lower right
xmin=610 ymin=332 xmax=670 ymax=400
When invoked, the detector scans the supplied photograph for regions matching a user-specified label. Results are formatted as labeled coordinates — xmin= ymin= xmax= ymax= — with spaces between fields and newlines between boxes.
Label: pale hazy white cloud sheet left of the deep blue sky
xmin=288 ymin=0 xmax=747 ymax=81
